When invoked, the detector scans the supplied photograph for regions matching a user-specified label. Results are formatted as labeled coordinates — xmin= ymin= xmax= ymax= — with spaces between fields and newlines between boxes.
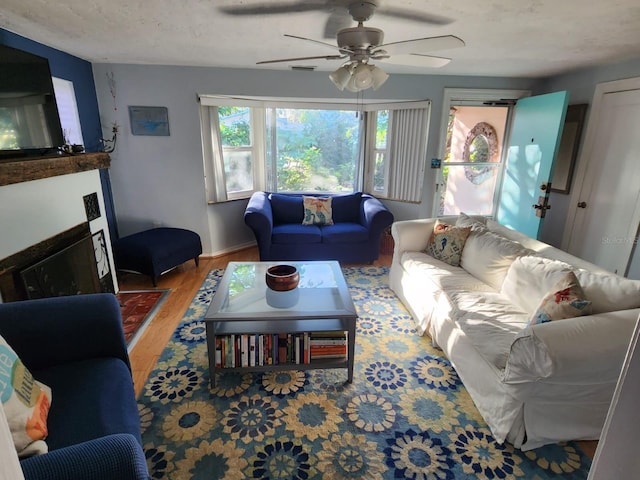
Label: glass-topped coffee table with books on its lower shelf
xmin=204 ymin=260 xmax=358 ymax=387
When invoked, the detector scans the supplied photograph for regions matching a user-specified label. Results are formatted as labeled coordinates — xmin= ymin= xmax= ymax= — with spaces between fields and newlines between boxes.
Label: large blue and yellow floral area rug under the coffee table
xmin=138 ymin=266 xmax=591 ymax=480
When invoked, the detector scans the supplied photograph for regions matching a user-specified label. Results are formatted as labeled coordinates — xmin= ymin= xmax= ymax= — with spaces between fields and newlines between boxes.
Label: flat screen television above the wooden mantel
xmin=0 ymin=45 xmax=65 ymax=158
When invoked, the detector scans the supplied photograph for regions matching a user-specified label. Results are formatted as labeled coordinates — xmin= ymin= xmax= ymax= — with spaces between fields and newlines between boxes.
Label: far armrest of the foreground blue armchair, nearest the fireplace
xmin=0 ymin=293 xmax=130 ymax=370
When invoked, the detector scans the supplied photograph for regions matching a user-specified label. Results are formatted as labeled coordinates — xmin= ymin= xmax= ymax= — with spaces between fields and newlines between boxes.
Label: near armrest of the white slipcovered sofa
xmin=503 ymin=308 xmax=640 ymax=385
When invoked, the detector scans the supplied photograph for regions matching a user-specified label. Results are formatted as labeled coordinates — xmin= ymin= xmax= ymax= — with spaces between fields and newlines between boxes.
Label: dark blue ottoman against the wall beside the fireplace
xmin=113 ymin=227 xmax=202 ymax=287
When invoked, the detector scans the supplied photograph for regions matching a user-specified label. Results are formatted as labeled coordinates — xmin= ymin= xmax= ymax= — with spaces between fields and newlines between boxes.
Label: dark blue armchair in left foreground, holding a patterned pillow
xmin=0 ymin=294 xmax=149 ymax=480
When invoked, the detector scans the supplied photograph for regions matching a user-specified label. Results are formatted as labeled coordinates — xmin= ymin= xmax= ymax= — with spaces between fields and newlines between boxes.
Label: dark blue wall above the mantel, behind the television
xmin=0 ymin=29 xmax=102 ymax=152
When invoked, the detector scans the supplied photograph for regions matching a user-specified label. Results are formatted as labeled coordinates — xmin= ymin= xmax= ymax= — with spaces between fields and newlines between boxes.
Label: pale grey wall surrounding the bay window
xmin=93 ymin=64 xmax=534 ymax=254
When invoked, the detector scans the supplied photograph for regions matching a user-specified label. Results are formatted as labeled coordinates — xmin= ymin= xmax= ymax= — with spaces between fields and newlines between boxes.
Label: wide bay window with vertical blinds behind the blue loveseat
xmin=200 ymin=95 xmax=430 ymax=203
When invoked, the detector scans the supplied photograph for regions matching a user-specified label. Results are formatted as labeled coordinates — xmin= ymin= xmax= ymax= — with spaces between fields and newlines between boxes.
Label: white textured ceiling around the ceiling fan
xmin=0 ymin=0 xmax=640 ymax=77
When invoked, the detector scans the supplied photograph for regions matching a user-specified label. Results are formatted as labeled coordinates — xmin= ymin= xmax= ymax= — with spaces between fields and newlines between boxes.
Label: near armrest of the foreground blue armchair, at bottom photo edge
xmin=20 ymin=433 xmax=150 ymax=480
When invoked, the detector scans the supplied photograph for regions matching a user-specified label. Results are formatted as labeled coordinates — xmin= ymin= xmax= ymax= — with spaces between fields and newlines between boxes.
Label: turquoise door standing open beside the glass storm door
xmin=497 ymin=92 xmax=569 ymax=238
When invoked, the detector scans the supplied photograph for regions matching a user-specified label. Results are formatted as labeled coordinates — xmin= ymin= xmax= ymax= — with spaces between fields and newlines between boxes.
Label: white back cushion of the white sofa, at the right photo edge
xmin=575 ymin=269 xmax=640 ymax=313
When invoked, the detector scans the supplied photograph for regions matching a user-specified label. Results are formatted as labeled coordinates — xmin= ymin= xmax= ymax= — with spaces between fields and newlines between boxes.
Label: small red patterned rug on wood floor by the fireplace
xmin=116 ymin=289 xmax=170 ymax=350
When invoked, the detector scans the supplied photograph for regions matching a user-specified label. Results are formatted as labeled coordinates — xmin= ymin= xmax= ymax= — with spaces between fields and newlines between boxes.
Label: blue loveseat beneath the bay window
xmin=244 ymin=192 xmax=393 ymax=263
